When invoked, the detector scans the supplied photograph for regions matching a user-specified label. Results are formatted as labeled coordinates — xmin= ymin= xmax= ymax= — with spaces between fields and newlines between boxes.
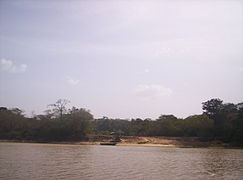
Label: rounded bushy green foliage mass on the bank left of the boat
xmin=0 ymin=101 xmax=93 ymax=141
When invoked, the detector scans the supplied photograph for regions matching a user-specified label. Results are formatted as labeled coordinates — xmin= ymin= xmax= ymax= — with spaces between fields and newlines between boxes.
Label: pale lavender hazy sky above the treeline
xmin=0 ymin=0 xmax=243 ymax=119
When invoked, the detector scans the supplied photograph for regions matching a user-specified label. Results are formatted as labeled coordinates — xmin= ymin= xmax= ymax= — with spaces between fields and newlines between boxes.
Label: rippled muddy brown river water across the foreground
xmin=0 ymin=143 xmax=243 ymax=180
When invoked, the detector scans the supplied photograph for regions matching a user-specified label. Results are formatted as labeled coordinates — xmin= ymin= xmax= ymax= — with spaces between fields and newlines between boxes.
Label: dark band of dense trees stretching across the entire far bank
xmin=0 ymin=99 xmax=243 ymax=145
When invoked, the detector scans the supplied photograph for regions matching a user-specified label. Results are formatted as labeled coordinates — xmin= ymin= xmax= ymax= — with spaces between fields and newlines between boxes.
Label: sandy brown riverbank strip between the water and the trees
xmin=0 ymin=135 xmax=242 ymax=148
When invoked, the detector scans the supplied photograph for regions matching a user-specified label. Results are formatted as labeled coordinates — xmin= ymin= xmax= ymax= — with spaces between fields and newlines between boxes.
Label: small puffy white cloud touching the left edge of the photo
xmin=0 ymin=58 xmax=27 ymax=73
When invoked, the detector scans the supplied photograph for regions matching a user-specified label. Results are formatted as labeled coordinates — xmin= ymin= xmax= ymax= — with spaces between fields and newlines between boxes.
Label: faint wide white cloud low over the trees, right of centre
xmin=135 ymin=84 xmax=172 ymax=100
